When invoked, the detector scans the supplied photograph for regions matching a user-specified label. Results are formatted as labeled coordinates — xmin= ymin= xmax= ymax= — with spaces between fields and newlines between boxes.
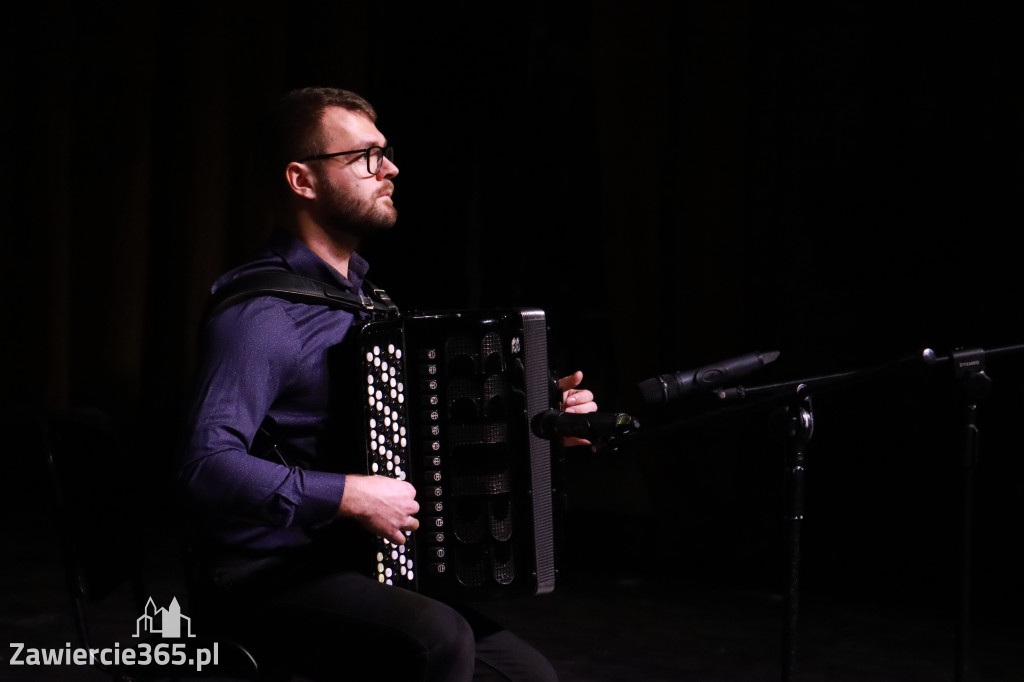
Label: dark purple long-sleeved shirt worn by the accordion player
xmin=180 ymin=232 xmax=368 ymax=550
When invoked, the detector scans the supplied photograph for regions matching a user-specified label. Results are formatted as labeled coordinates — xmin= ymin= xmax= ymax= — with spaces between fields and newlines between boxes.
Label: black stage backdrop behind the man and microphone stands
xmin=0 ymin=0 xmax=1024 ymax=675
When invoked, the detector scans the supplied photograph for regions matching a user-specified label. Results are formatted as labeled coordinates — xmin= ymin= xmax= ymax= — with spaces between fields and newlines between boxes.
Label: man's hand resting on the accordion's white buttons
xmin=338 ymin=474 xmax=420 ymax=545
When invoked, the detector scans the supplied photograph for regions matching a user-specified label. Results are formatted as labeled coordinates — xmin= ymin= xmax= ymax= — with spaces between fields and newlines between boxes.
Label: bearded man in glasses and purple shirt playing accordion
xmin=180 ymin=88 xmax=597 ymax=682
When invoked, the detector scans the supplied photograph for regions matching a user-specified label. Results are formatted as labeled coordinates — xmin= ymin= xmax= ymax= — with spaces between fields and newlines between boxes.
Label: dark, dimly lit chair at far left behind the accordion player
xmin=41 ymin=409 xmax=260 ymax=682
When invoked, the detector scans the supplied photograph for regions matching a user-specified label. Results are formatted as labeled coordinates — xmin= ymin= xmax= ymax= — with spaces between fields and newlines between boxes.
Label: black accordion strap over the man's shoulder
xmin=207 ymin=271 xmax=398 ymax=316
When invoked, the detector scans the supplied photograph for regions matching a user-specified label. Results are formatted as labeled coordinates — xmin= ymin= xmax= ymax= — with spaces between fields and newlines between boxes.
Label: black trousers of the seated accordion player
xmin=193 ymin=556 xmax=557 ymax=682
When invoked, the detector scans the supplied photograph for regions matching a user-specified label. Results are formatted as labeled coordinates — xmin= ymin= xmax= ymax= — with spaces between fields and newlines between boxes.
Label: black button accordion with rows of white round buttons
xmin=359 ymin=309 xmax=555 ymax=599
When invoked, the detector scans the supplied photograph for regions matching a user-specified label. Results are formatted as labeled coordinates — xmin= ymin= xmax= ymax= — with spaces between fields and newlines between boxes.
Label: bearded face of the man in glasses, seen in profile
xmin=312 ymin=106 xmax=398 ymax=239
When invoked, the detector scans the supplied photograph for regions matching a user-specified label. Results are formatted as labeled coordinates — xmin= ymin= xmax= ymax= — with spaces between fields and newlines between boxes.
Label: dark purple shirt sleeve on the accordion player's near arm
xmin=180 ymin=299 xmax=345 ymax=527
